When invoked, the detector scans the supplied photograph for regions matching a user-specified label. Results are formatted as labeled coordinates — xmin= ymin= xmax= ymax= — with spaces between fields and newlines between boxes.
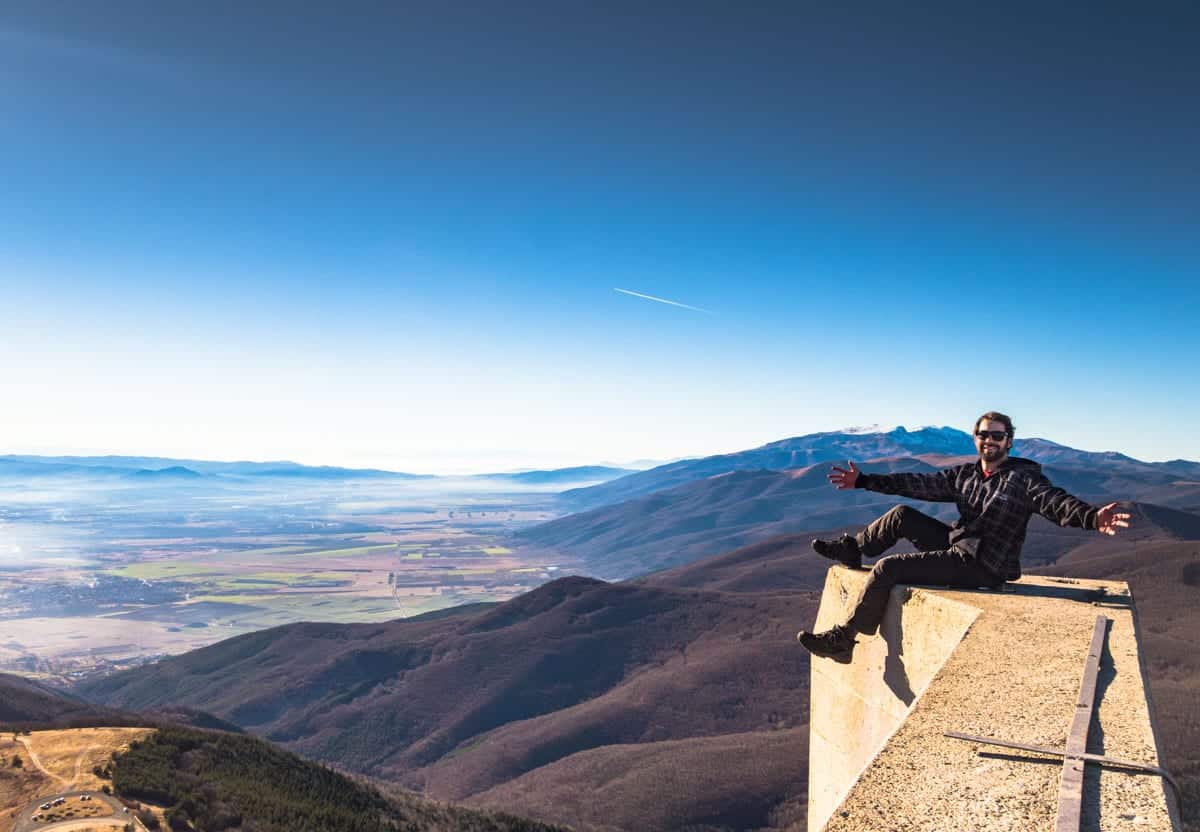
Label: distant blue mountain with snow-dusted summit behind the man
xmin=523 ymin=427 xmax=1200 ymax=580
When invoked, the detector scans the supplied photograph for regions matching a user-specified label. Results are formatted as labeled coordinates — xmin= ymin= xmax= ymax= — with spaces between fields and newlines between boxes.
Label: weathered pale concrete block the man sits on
xmin=809 ymin=567 xmax=1180 ymax=832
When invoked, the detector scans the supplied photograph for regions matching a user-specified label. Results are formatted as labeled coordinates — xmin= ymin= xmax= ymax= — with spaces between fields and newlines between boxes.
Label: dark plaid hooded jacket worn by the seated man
xmin=854 ymin=456 xmax=1098 ymax=581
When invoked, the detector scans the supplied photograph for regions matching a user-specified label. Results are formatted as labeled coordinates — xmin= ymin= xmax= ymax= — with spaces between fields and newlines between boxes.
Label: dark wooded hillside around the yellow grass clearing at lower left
xmin=0 ymin=675 xmax=565 ymax=832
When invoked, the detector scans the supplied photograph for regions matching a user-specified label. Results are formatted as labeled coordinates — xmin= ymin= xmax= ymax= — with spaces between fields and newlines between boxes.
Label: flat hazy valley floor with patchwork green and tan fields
xmin=0 ymin=473 xmax=574 ymax=681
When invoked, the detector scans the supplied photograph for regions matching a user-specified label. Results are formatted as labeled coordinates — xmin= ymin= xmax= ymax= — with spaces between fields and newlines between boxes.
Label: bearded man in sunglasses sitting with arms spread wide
xmin=796 ymin=412 xmax=1129 ymax=662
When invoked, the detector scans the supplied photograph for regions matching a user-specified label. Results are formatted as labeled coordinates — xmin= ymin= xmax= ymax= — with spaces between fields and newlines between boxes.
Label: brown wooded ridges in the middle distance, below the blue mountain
xmin=72 ymin=516 xmax=1200 ymax=832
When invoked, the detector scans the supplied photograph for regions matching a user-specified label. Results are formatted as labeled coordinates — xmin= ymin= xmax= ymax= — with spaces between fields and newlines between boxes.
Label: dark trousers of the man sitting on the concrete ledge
xmin=848 ymin=505 xmax=1004 ymax=633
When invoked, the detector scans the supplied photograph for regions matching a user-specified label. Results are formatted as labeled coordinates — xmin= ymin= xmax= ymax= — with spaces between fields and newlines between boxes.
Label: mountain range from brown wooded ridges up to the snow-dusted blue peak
xmin=9 ymin=429 xmax=1200 ymax=832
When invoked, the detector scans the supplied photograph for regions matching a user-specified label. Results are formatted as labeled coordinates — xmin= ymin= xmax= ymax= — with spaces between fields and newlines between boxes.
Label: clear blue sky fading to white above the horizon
xmin=0 ymin=0 xmax=1200 ymax=472
